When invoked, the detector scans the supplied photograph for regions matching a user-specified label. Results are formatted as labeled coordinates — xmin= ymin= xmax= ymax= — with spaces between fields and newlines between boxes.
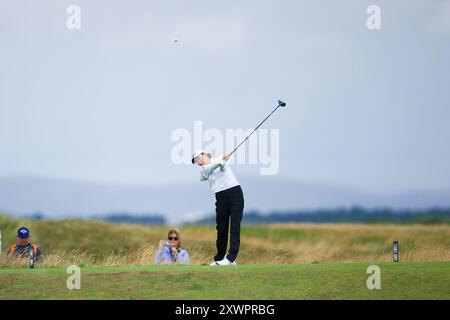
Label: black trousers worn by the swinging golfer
xmin=214 ymin=186 xmax=244 ymax=262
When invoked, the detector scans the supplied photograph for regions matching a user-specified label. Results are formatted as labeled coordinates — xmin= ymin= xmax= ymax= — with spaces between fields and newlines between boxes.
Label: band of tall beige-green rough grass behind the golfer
xmin=0 ymin=220 xmax=450 ymax=267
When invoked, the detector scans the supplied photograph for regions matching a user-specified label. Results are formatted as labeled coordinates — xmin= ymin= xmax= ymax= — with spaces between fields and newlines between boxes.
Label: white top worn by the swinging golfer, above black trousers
xmin=200 ymin=159 xmax=239 ymax=193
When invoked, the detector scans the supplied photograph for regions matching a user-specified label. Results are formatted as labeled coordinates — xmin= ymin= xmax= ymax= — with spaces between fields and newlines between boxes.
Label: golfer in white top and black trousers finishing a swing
xmin=192 ymin=151 xmax=244 ymax=266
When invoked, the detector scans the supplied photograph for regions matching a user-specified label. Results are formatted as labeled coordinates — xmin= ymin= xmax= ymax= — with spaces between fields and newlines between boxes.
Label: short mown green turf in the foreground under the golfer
xmin=0 ymin=262 xmax=450 ymax=299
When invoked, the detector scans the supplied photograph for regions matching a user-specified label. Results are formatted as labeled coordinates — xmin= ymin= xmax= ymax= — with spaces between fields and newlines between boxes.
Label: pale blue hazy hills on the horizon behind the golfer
xmin=0 ymin=175 xmax=450 ymax=223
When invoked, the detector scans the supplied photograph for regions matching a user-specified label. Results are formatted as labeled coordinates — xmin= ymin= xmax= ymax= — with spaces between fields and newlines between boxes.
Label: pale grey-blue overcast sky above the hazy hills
xmin=0 ymin=0 xmax=450 ymax=193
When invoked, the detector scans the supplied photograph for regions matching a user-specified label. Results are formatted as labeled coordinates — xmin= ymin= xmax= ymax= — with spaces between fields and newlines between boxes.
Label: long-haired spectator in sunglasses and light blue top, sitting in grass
xmin=155 ymin=229 xmax=189 ymax=264
